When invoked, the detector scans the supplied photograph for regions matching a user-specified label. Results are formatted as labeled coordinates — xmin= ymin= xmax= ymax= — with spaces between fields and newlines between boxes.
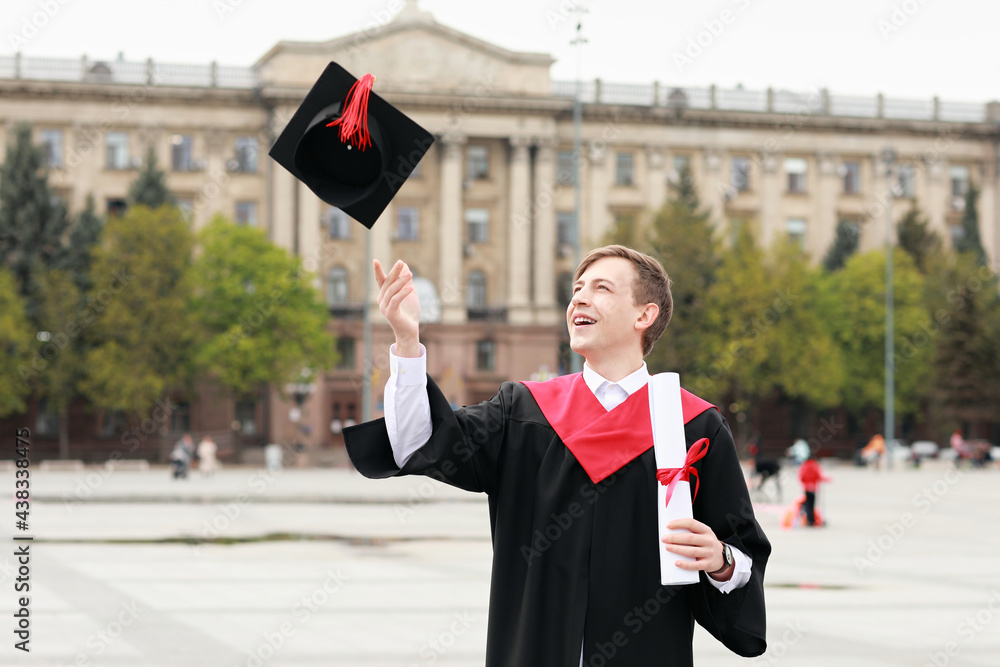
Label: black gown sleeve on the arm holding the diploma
xmin=685 ymin=410 xmax=771 ymax=657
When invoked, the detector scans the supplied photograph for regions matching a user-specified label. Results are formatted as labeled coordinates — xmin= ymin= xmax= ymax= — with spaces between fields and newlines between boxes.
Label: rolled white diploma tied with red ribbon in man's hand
xmin=649 ymin=373 xmax=698 ymax=586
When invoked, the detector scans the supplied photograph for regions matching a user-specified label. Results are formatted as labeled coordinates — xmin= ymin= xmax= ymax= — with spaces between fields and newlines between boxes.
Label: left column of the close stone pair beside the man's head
xmin=507 ymin=137 xmax=533 ymax=324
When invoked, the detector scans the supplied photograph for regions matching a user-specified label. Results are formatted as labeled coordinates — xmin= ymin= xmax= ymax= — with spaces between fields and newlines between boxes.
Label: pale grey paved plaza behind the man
xmin=0 ymin=462 xmax=1000 ymax=667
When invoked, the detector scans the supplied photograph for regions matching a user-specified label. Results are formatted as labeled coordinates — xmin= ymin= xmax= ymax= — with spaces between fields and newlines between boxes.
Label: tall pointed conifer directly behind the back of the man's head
xmin=646 ymin=162 xmax=720 ymax=378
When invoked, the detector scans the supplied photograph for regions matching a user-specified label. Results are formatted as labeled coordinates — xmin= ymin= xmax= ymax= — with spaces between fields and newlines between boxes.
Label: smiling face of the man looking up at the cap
xmin=566 ymin=257 xmax=645 ymax=358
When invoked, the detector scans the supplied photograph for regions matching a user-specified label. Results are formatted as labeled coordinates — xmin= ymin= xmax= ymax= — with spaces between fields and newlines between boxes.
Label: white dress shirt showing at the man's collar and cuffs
xmin=385 ymin=344 xmax=753 ymax=665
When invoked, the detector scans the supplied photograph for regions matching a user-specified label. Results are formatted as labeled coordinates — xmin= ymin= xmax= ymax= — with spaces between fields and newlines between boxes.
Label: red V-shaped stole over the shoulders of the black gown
xmin=522 ymin=373 xmax=715 ymax=484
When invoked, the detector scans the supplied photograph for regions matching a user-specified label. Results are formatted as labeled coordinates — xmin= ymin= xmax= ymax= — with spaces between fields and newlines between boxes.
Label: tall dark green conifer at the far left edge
xmin=0 ymin=124 xmax=69 ymax=319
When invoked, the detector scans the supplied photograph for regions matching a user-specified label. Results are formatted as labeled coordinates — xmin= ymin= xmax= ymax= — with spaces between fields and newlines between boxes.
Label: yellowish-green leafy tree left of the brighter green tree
xmin=81 ymin=205 xmax=196 ymax=422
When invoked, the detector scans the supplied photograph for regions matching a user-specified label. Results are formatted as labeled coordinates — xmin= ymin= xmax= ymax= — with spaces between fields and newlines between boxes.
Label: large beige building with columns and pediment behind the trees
xmin=0 ymin=2 xmax=1000 ymax=460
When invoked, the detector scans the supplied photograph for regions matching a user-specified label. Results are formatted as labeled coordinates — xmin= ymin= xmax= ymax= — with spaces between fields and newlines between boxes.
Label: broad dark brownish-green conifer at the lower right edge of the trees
xmin=930 ymin=254 xmax=1000 ymax=435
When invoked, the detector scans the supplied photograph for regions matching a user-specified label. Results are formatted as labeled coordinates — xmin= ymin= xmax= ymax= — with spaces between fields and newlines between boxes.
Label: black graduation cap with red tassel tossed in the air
xmin=269 ymin=63 xmax=434 ymax=229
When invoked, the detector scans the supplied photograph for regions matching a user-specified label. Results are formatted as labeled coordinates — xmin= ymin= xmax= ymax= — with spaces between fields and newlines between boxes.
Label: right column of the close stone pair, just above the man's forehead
xmin=532 ymin=137 xmax=562 ymax=325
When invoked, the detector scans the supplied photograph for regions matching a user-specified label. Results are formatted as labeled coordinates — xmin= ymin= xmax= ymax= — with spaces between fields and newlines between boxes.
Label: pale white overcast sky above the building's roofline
xmin=0 ymin=0 xmax=1000 ymax=102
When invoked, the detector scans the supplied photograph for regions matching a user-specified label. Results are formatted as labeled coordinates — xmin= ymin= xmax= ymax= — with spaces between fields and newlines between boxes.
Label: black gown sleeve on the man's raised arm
xmin=344 ymin=376 xmax=514 ymax=494
